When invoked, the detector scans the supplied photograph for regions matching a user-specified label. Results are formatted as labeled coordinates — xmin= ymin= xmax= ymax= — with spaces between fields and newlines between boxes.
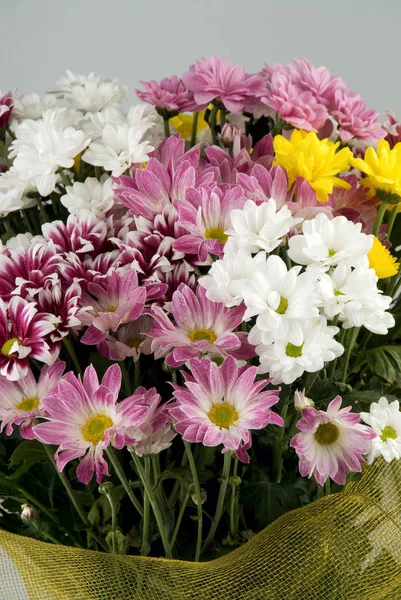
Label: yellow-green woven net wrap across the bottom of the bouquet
xmin=0 ymin=460 xmax=401 ymax=600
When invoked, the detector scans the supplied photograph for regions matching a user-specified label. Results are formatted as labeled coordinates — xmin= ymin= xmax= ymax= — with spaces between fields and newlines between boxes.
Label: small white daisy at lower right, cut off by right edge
xmin=361 ymin=396 xmax=401 ymax=463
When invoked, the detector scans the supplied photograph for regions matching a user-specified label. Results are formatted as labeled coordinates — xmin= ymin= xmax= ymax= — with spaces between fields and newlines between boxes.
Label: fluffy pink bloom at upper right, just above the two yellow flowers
xmin=331 ymin=90 xmax=386 ymax=142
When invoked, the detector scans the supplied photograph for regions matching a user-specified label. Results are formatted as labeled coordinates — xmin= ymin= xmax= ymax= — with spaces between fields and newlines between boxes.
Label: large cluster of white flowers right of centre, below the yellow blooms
xmin=200 ymin=206 xmax=394 ymax=384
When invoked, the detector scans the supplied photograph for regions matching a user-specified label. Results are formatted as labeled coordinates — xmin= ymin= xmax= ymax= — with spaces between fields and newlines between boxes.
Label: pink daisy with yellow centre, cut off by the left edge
xmin=0 ymin=360 xmax=65 ymax=440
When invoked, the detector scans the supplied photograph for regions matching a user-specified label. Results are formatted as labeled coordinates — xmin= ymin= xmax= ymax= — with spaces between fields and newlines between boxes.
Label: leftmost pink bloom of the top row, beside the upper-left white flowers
xmin=135 ymin=75 xmax=197 ymax=116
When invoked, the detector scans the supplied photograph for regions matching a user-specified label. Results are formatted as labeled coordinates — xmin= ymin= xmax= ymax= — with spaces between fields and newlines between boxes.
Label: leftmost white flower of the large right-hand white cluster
xmin=199 ymin=240 xmax=266 ymax=307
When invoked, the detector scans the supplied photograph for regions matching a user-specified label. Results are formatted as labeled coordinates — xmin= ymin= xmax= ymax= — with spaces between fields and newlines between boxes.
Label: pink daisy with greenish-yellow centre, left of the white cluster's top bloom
xmin=174 ymin=186 xmax=246 ymax=262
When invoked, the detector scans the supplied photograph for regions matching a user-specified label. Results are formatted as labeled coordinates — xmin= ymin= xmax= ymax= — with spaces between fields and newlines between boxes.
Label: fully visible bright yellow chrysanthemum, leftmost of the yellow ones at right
xmin=273 ymin=129 xmax=352 ymax=202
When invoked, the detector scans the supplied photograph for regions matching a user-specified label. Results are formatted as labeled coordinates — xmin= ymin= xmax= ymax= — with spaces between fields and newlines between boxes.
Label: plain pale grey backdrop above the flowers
xmin=0 ymin=0 xmax=401 ymax=117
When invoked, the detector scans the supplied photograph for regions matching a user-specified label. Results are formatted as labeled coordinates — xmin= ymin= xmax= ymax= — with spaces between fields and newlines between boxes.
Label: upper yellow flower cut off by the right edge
xmin=351 ymin=140 xmax=401 ymax=204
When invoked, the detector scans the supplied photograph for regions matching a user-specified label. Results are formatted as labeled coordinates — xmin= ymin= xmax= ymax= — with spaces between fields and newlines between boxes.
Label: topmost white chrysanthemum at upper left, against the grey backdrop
xmin=56 ymin=70 xmax=127 ymax=112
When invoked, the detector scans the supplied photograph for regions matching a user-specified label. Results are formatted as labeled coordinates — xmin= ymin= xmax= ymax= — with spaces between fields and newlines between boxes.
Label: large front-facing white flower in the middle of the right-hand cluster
xmin=242 ymin=254 xmax=319 ymax=344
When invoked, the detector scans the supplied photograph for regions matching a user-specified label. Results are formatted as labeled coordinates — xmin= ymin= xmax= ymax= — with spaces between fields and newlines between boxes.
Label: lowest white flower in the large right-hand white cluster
xmin=252 ymin=317 xmax=344 ymax=384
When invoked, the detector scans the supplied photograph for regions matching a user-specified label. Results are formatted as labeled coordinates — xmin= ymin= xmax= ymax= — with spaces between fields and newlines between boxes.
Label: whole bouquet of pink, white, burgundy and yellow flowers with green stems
xmin=0 ymin=56 xmax=401 ymax=580
